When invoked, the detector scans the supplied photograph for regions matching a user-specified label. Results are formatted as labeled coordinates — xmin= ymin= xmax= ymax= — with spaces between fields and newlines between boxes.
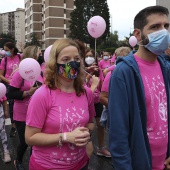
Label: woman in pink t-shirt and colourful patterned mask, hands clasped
xmin=25 ymin=39 xmax=95 ymax=170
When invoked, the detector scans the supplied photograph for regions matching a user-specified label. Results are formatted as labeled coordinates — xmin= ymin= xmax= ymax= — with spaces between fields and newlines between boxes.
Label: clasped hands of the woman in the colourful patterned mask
xmin=67 ymin=127 xmax=90 ymax=147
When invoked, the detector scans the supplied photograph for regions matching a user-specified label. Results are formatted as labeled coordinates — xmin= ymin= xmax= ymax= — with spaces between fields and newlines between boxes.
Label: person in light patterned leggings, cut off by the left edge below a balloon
xmin=0 ymin=96 xmax=11 ymax=163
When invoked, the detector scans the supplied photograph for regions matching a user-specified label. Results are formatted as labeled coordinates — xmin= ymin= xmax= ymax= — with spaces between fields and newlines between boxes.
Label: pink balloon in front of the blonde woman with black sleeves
xmin=19 ymin=58 xmax=41 ymax=81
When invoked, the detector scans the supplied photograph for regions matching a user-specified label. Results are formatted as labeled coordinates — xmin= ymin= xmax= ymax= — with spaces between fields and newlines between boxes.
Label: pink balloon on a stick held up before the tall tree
xmin=87 ymin=16 xmax=106 ymax=38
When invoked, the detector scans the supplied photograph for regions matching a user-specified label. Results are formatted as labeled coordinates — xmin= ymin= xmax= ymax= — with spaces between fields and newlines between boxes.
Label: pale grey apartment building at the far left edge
xmin=0 ymin=8 xmax=25 ymax=50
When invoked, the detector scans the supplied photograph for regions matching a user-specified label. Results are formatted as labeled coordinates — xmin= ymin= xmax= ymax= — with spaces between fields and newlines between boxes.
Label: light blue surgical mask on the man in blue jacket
xmin=144 ymin=29 xmax=170 ymax=55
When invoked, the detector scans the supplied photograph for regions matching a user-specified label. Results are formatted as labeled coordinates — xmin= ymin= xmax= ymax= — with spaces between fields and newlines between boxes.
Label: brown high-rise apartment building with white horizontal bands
xmin=25 ymin=0 xmax=74 ymax=49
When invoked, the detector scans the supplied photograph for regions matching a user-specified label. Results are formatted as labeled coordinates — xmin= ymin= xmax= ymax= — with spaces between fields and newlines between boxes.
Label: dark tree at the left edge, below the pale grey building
xmin=0 ymin=33 xmax=16 ymax=48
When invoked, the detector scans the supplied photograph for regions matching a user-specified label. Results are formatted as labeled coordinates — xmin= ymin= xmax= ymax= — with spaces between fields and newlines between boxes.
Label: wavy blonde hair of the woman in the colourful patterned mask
xmin=45 ymin=39 xmax=85 ymax=96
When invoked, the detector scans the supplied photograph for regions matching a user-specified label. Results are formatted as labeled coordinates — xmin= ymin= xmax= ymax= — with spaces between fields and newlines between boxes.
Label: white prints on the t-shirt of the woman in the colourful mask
xmin=50 ymin=106 xmax=85 ymax=163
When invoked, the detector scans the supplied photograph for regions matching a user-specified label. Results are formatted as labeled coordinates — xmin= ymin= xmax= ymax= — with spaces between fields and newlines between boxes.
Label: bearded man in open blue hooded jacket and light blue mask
xmin=108 ymin=6 xmax=170 ymax=170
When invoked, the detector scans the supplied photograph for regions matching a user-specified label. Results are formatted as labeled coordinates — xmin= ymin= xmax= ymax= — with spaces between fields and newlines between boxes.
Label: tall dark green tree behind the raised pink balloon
xmin=69 ymin=0 xmax=110 ymax=48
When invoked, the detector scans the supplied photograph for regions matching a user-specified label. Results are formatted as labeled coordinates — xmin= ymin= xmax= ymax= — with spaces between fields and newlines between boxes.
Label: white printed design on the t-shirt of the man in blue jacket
xmin=145 ymin=75 xmax=167 ymax=139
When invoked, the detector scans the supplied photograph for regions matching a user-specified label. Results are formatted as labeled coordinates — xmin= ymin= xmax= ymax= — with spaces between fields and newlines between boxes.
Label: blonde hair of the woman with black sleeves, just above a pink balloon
xmin=22 ymin=45 xmax=40 ymax=60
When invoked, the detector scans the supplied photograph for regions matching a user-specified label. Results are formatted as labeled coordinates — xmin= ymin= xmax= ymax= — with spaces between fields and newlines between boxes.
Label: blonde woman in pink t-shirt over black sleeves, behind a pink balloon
xmin=9 ymin=46 xmax=43 ymax=169
